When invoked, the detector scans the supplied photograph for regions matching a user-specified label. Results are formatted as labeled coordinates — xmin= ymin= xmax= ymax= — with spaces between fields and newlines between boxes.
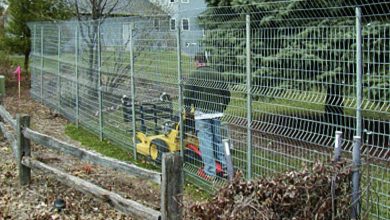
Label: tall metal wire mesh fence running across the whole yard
xmin=30 ymin=1 xmax=390 ymax=219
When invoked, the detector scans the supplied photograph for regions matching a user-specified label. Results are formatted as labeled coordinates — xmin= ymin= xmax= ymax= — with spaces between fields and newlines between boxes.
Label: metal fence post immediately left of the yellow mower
xmin=130 ymin=23 xmax=137 ymax=160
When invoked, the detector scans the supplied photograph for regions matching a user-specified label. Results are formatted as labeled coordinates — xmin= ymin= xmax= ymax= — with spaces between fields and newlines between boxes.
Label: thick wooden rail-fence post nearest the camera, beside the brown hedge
xmin=161 ymin=153 xmax=184 ymax=220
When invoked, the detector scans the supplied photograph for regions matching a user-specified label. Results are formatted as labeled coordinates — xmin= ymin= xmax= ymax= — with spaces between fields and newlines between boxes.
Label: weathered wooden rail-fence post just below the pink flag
xmin=16 ymin=114 xmax=31 ymax=186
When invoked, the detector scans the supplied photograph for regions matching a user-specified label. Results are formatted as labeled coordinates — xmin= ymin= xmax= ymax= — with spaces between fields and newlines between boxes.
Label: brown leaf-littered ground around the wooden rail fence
xmin=0 ymin=90 xmax=177 ymax=220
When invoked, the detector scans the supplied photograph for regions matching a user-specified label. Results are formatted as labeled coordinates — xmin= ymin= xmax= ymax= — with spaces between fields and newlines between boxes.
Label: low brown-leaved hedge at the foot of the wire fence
xmin=189 ymin=162 xmax=351 ymax=220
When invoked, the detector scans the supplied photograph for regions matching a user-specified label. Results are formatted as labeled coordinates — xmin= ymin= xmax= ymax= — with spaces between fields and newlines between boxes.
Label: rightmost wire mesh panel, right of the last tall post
xmin=361 ymin=21 xmax=390 ymax=219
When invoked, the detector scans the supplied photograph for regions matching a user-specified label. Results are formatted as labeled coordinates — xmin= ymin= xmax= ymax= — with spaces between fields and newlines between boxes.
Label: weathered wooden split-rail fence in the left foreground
xmin=0 ymin=106 xmax=183 ymax=220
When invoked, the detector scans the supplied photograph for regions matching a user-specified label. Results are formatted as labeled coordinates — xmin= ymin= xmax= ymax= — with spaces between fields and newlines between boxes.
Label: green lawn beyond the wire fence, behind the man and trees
xmin=33 ymin=50 xmax=390 ymax=120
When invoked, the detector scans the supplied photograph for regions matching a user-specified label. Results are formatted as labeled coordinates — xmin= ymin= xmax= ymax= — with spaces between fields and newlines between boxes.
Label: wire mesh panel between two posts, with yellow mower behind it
xmin=133 ymin=17 xmax=181 ymax=161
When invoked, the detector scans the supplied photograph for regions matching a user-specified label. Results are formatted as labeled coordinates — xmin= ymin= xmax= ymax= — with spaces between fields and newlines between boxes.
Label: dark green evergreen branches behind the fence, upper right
xmin=200 ymin=0 xmax=390 ymax=101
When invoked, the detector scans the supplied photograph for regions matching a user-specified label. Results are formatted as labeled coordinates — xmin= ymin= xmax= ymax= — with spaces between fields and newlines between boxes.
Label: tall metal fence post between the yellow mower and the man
xmin=176 ymin=22 xmax=184 ymax=157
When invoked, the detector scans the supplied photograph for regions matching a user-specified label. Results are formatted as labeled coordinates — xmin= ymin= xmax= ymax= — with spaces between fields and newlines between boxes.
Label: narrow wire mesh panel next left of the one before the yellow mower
xmin=101 ymin=21 xmax=133 ymax=148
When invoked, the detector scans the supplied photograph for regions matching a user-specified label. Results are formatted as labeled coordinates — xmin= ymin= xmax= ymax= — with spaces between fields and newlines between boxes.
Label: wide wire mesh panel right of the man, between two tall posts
xmin=252 ymin=26 xmax=355 ymax=176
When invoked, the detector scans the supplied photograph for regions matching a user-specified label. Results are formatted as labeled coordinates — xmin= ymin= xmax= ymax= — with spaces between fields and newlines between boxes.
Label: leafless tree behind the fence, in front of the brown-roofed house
xmin=71 ymin=0 xmax=174 ymax=102
